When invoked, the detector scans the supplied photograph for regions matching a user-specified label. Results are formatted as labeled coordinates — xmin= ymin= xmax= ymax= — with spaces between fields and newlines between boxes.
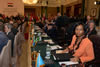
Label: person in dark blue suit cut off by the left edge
xmin=0 ymin=22 xmax=8 ymax=53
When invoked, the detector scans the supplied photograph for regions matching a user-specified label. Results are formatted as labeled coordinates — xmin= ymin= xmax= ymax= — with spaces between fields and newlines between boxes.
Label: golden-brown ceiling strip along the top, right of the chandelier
xmin=25 ymin=0 xmax=77 ymax=7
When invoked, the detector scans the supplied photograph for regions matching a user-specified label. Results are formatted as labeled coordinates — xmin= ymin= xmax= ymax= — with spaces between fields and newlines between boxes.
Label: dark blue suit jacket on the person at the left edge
xmin=0 ymin=31 xmax=8 ymax=53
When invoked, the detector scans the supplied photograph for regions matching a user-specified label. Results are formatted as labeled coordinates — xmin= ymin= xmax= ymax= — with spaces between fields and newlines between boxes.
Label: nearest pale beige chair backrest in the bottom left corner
xmin=0 ymin=40 xmax=11 ymax=67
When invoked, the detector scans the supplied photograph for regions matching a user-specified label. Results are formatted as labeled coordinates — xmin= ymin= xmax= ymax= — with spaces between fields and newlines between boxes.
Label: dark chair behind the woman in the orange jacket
xmin=88 ymin=35 xmax=100 ymax=67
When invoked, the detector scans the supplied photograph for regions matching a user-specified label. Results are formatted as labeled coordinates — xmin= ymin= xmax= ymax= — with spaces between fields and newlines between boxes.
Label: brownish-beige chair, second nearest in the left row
xmin=12 ymin=32 xmax=25 ymax=67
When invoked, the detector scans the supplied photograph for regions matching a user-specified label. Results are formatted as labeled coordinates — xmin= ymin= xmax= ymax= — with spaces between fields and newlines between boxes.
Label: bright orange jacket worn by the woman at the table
xmin=69 ymin=35 xmax=94 ymax=63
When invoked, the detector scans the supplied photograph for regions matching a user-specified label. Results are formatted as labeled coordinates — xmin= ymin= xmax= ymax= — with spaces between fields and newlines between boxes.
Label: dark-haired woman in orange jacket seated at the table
xmin=63 ymin=22 xmax=94 ymax=63
